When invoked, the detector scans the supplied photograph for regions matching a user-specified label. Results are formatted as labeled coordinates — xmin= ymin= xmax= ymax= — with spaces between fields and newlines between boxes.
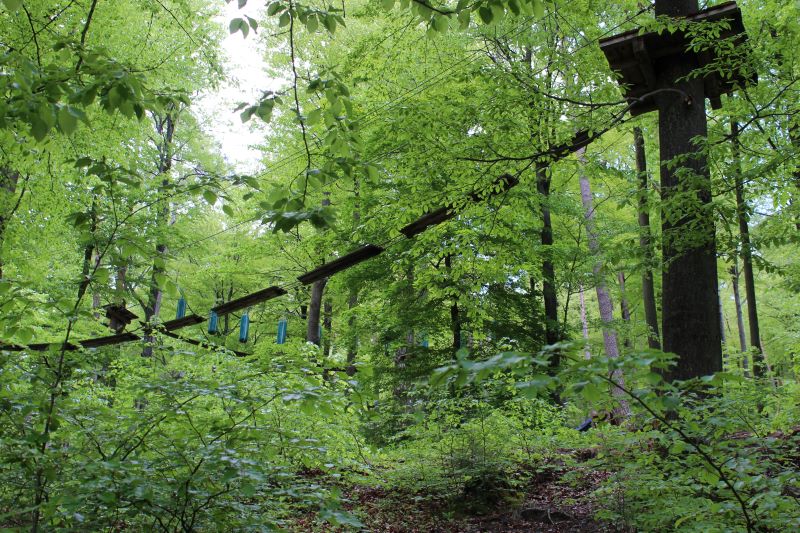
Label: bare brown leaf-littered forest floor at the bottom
xmin=296 ymin=451 xmax=614 ymax=533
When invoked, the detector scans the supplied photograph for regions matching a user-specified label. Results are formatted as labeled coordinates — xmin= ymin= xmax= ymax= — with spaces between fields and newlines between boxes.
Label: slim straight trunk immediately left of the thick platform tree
xmin=633 ymin=126 xmax=661 ymax=350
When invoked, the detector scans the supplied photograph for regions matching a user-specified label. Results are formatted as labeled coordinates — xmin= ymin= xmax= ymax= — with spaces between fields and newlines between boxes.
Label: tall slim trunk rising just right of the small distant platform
xmin=142 ymin=111 xmax=176 ymax=357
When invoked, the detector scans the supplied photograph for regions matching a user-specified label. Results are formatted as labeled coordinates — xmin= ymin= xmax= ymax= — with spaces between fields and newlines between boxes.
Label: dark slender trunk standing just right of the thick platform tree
xmin=731 ymin=122 xmax=764 ymax=377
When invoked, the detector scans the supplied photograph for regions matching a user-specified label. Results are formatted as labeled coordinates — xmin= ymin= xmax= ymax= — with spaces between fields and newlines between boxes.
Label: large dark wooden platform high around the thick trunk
xmin=600 ymin=2 xmax=757 ymax=116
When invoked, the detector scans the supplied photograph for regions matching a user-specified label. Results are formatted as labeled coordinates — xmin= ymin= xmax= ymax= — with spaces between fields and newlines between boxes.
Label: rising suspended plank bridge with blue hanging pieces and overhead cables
xmin=0 ymin=8 xmax=664 ymax=356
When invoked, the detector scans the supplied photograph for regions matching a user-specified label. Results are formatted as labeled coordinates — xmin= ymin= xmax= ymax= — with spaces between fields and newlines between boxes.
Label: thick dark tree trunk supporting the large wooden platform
xmin=654 ymin=0 xmax=722 ymax=379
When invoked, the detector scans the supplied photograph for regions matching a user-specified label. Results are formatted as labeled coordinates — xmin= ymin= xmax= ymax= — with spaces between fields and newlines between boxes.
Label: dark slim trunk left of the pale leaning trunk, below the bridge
xmin=536 ymin=163 xmax=561 ymax=367
